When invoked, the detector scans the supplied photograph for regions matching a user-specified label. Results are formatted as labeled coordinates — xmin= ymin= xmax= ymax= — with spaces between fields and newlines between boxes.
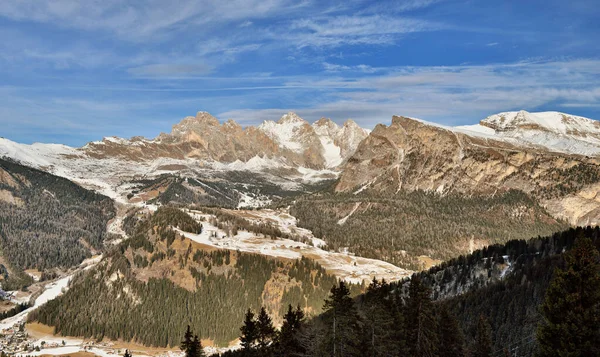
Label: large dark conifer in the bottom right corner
xmin=537 ymin=237 xmax=600 ymax=357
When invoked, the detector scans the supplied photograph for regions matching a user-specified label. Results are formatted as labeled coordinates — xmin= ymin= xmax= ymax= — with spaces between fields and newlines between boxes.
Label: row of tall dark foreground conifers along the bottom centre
xmin=215 ymin=276 xmax=492 ymax=357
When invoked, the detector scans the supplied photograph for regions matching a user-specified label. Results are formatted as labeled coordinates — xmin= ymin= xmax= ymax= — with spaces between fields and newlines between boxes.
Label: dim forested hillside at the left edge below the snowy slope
xmin=0 ymin=159 xmax=114 ymax=290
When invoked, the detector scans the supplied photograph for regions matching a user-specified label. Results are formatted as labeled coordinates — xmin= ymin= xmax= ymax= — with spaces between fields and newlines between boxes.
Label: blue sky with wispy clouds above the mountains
xmin=0 ymin=0 xmax=600 ymax=146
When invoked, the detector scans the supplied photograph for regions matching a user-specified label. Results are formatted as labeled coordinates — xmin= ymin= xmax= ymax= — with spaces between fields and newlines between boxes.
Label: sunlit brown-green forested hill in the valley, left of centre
xmin=30 ymin=207 xmax=361 ymax=346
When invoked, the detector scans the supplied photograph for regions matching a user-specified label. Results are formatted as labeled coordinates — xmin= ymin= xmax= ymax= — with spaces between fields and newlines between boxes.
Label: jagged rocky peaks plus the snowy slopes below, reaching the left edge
xmin=0 ymin=112 xmax=369 ymax=206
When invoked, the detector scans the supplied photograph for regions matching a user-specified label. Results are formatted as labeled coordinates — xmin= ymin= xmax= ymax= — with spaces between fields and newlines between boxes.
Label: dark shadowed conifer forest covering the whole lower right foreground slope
xmin=211 ymin=227 xmax=600 ymax=357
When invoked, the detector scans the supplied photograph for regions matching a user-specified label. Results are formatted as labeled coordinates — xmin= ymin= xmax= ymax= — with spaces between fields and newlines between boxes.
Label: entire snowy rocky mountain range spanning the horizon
xmin=0 ymin=111 xmax=600 ymax=225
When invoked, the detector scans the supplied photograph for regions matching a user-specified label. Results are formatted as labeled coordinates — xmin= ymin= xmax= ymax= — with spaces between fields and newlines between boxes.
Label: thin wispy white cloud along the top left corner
xmin=0 ymin=0 xmax=297 ymax=41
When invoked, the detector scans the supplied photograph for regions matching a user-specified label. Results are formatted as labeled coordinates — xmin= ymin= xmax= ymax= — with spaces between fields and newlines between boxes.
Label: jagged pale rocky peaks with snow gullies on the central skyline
xmin=81 ymin=112 xmax=368 ymax=170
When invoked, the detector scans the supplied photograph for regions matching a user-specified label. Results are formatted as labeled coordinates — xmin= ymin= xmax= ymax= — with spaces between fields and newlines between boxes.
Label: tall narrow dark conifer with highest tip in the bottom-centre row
xmin=406 ymin=275 xmax=438 ymax=357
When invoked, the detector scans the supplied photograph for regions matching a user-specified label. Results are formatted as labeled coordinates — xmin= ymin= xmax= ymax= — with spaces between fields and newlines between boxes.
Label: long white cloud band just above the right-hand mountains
xmin=221 ymin=59 xmax=600 ymax=127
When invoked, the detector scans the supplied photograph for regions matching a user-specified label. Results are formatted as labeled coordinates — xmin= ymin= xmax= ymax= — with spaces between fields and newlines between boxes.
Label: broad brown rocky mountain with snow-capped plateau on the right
xmin=335 ymin=111 xmax=600 ymax=225
